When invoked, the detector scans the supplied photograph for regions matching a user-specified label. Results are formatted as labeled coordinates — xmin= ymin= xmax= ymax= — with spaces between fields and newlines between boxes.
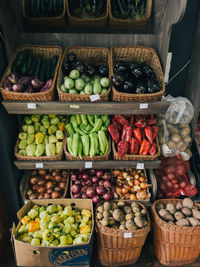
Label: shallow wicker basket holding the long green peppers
xmin=64 ymin=138 xmax=111 ymax=161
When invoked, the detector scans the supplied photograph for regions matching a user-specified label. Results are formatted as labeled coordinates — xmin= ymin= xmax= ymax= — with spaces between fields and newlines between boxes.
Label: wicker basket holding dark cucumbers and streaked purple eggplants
xmin=0 ymin=45 xmax=62 ymax=101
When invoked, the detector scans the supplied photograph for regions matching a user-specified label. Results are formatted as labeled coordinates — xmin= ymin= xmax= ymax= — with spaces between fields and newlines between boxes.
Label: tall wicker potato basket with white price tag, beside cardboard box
xmin=95 ymin=201 xmax=151 ymax=266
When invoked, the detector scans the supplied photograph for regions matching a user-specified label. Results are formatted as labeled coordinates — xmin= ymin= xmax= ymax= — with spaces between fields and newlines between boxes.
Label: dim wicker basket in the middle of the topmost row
xmin=67 ymin=0 xmax=108 ymax=31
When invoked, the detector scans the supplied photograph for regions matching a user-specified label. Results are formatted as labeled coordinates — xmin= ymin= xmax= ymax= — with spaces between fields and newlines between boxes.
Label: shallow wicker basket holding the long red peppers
xmin=112 ymin=137 xmax=160 ymax=160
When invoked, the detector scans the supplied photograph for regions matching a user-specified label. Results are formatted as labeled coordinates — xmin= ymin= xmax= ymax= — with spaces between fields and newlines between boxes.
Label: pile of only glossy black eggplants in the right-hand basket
xmin=112 ymin=61 xmax=159 ymax=94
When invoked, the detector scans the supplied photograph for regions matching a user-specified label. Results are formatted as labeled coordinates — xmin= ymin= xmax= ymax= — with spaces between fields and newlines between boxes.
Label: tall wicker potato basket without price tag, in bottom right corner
xmin=152 ymin=199 xmax=200 ymax=266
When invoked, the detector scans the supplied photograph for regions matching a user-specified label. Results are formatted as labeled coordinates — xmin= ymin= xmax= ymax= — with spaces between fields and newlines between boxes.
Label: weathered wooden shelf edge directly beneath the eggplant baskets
xmin=2 ymin=101 xmax=169 ymax=114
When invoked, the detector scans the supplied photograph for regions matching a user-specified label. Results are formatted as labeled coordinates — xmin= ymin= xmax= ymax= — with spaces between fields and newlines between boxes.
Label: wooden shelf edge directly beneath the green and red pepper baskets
xmin=14 ymin=160 xmax=160 ymax=170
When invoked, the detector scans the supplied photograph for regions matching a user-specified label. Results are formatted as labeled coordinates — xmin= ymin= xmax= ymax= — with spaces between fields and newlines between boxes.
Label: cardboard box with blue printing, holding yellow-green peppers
xmin=11 ymin=199 xmax=94 ymax=267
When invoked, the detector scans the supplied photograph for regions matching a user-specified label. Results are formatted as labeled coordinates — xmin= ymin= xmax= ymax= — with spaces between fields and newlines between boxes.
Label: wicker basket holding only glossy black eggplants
xmin=111 ymin=46 xmax=165 ymax=102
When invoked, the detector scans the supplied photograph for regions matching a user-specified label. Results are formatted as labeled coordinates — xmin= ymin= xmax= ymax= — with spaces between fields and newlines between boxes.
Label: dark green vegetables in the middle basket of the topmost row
xmin=69 ymin=0 xmax=107 ymax=19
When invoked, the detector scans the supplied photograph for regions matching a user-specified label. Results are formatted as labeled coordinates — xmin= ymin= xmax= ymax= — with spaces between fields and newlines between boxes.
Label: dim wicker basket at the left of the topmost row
xmin=22 ymin=0 xmax=66 ymax=30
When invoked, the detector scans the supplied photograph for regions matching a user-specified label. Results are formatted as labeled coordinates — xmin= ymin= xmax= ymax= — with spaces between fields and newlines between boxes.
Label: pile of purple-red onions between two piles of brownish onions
xmin=70 ymin=170 xmax=114 ymax=204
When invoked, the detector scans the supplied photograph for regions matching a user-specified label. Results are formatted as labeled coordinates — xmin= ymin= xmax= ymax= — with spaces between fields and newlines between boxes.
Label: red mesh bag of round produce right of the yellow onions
xmin=154 ymin=154 xmax=198 ymax=201
